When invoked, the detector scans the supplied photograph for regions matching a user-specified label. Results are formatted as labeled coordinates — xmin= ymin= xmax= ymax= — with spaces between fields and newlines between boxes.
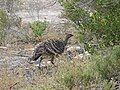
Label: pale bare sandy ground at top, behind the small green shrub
xmin=16 ymin=0 xmax=69 ymax=33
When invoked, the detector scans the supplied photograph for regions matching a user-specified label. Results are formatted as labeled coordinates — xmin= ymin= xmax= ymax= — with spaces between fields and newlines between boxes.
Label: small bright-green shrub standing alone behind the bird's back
xmin=30 ymin=21 xmax=47 ymax=37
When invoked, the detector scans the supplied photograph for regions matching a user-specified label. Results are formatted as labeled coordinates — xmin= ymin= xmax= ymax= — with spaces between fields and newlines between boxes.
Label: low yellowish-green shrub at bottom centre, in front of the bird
xmin=54 ymin=61 xmax=81 ymax=90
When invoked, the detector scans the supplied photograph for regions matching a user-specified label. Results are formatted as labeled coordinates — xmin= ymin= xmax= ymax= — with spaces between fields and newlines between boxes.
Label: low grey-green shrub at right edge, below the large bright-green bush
xmin=82 ymin=46 xmax=120 ymax=87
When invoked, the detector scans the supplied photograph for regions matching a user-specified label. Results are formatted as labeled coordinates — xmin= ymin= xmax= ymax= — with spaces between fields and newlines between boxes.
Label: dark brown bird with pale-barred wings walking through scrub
xmin=29 ymin=34 xmax=73 ymax=67
